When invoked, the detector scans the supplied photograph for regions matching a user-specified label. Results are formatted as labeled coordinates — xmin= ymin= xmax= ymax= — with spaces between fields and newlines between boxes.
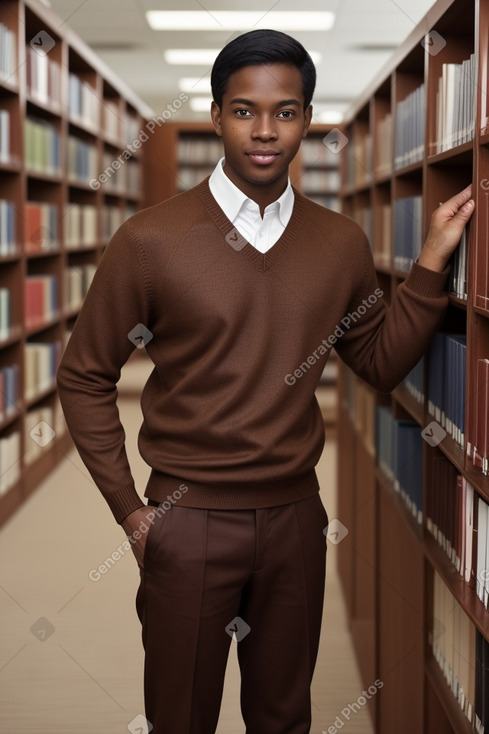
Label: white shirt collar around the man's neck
xmin=209 ymin=156 xmax=294 ymax=227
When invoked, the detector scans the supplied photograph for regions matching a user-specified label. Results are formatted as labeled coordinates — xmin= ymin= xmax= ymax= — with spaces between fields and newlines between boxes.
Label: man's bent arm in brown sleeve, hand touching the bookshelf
xmin=336 ymin=187 xmax=474 ymax=392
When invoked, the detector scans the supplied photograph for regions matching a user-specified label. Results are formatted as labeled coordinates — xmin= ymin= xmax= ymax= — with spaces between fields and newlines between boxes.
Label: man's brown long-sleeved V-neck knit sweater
xmin=58 ymin=179 xmax=447 ymax=522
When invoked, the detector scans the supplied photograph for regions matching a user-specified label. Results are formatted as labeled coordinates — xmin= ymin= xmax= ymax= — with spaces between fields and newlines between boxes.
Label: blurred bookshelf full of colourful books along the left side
xmin=0 ymin=0 xmax=153 ymax=525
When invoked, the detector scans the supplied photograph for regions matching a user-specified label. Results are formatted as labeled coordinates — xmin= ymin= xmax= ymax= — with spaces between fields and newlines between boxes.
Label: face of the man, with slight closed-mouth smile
xmin=211 ymin=64 xmax=312 ymax=200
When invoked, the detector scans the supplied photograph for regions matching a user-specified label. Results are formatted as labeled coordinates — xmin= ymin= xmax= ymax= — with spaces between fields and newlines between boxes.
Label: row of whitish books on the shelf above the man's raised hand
xmin=436 ymin=54 xmax=477 ymax=153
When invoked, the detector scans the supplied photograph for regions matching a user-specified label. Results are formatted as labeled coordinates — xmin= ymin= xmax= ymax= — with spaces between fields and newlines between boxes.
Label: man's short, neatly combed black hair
xmin=211 ymin=29 xmax=316 ymax=109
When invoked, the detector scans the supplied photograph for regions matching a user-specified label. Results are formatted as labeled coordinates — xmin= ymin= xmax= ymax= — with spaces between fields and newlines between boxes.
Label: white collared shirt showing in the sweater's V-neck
xmin=209 ymin=157 xmax=294 ymax=252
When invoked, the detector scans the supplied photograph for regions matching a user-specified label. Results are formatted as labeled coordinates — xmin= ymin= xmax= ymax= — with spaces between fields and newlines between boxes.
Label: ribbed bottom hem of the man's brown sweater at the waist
xmin=144 ymin=469 xmax=319 ymax=510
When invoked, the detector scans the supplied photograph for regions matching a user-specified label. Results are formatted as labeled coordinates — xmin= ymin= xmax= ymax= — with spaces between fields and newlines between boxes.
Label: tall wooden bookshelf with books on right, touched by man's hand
xmin=338 ymin=0 xmax=489 ymax=734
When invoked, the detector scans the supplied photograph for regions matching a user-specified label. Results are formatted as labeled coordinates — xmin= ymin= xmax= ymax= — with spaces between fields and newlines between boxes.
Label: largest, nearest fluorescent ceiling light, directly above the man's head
xmin=146 ymin=10 xmax=335 ymax=32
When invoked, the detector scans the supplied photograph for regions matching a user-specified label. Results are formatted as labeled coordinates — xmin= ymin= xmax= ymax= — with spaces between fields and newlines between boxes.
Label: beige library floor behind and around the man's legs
xmin=0 ymin=363 xmax=373 ymax=734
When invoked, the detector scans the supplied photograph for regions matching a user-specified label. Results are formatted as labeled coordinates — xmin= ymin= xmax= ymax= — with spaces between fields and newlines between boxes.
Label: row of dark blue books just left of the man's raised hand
xmin=393 ymin=196 xmax=423 ymax=272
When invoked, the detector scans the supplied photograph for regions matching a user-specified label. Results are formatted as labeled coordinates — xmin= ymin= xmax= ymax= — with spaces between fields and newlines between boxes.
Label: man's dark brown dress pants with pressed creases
xmin=136 ymin=494 xmax=328 ymax=734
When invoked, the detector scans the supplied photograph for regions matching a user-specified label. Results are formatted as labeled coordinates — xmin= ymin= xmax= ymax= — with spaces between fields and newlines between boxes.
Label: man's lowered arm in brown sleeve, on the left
xmin=57 ymin=222 xmax=151 ymax=523
